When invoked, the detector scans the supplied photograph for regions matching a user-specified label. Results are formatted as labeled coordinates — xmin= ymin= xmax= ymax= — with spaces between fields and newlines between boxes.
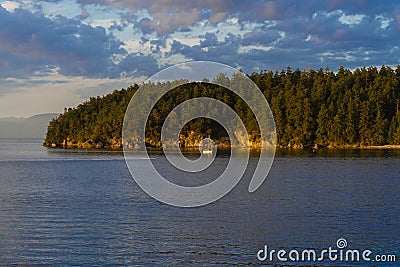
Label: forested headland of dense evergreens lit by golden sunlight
xmin=43 ymin=65 xmax=400 ymax=149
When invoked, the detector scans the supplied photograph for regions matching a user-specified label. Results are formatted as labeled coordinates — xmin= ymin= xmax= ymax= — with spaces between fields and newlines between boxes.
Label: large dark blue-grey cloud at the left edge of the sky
xmin=0 ymin=7 xmax=125 ymax=77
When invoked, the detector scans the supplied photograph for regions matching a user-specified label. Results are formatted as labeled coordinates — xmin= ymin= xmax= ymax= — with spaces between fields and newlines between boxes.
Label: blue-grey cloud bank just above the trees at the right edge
xmin=268 ymin=8 xmax=400 ymax=69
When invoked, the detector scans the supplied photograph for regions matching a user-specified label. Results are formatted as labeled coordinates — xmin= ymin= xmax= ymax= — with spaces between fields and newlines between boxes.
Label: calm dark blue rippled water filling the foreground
xmin=0 ymin=139 xmax=400 ymax=266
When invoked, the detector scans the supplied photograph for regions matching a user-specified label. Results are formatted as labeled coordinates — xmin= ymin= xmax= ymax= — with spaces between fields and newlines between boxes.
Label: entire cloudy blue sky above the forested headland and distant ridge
xmin=0 ymin=0 xmax=400 ymax=117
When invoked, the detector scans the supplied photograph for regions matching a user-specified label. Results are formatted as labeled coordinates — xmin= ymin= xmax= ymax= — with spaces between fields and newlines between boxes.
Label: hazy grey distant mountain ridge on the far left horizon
xmin=0 ymin=113 xmax=59 ymax=139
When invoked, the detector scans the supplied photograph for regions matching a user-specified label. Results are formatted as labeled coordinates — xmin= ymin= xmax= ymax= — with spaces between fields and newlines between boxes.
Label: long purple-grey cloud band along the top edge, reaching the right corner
xmin=79 ymin=0 xmax=398 ymax=34
